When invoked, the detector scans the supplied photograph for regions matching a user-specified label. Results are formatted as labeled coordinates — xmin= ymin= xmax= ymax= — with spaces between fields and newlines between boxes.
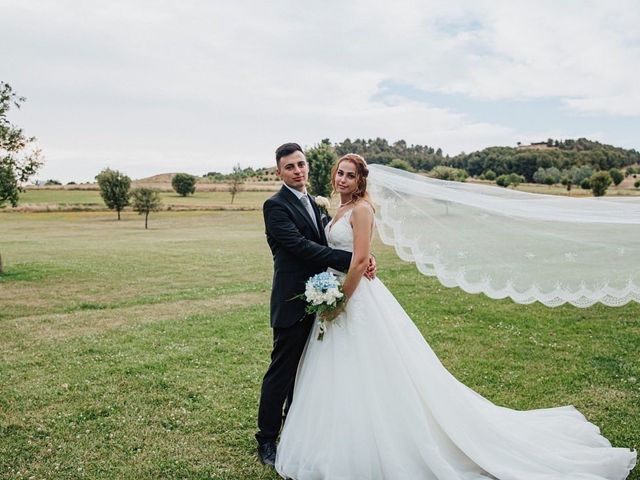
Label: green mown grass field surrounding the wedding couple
xmin=0 ymin=212 xmax=640 ymax=480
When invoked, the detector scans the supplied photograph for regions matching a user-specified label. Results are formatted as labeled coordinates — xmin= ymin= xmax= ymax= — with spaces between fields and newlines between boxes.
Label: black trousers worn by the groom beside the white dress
xmin=256 ymin=315 xmax=314 ymax=445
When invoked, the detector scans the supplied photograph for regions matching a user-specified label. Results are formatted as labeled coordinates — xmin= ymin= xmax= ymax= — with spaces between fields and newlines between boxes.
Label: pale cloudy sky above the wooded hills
xmin=0 ymin=0 xmax=640 ymax=182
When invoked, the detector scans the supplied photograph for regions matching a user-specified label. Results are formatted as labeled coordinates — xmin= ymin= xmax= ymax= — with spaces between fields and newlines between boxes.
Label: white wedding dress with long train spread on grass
xmin=276 ymin=212 xmax=636 ymax=480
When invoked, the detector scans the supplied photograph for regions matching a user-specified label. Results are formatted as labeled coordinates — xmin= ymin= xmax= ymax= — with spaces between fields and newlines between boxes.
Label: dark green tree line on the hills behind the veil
xmin=316 ymin=138 xmax=640 ymax=196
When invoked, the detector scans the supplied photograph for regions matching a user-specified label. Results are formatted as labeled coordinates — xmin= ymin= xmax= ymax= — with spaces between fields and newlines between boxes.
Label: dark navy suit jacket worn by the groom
xmin=262 ymin=185 xmax=351 ymax=328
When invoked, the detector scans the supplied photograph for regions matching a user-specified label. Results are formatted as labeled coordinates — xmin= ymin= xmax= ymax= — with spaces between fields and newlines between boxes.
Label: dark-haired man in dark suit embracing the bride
xmin=256 ymin=143 xmax=376 ymax=465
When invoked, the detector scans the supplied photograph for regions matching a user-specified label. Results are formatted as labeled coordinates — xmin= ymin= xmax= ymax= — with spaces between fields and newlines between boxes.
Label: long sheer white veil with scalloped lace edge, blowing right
xmin=369 ymin=165 xmax=640 ymax=307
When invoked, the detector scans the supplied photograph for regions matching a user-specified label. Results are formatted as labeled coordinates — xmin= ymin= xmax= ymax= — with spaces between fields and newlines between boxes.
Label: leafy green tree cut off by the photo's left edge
xmin=0 ymin=81 xmax=42 ymax=207
